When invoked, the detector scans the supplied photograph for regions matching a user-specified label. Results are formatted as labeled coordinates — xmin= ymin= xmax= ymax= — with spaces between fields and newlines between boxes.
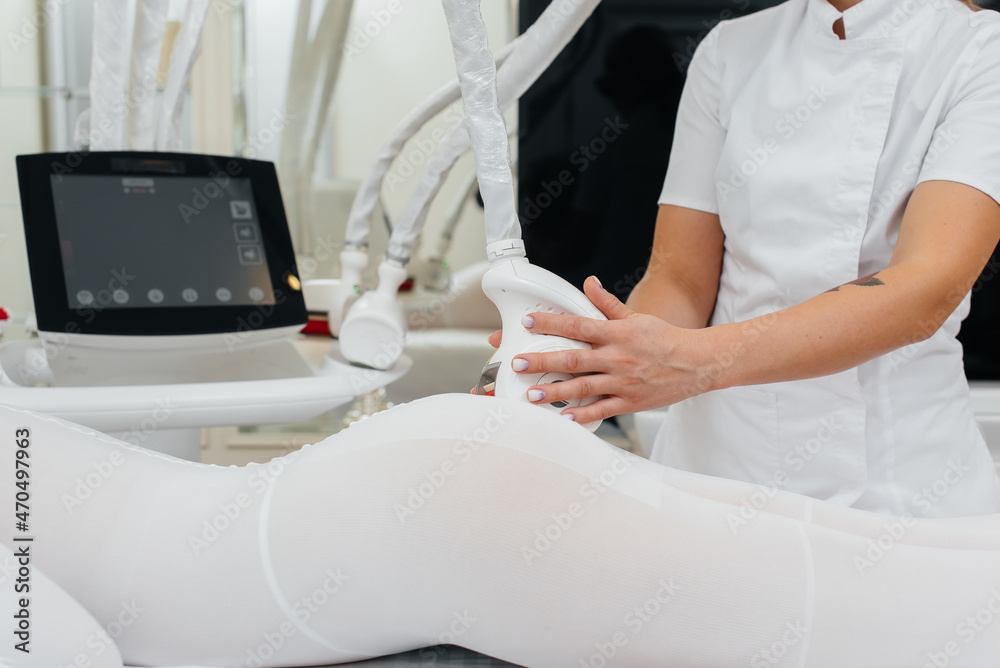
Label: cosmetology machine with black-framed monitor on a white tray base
xmin=0 ymin=152 xmax=409 ymax=459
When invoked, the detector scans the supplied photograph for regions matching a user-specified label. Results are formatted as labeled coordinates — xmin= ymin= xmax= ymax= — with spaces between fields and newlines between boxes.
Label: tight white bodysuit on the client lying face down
xmin=0 ymin=395 xmax=1000 ymax=668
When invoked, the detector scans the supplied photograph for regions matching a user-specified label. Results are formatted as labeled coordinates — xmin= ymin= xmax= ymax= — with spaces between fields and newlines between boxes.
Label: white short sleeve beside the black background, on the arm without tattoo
xmin=660 ymin=23 xmax=726 ymax=213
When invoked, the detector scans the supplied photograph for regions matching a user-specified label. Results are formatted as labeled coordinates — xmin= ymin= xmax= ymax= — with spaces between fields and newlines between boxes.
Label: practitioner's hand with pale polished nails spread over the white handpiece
xmin=512 ymin=277 xmax=713 ymax=424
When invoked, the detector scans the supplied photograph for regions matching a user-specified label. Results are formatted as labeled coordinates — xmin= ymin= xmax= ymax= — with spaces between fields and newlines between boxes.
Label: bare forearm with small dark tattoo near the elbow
xmin=698 ymin=263 xmax=971 ymax=389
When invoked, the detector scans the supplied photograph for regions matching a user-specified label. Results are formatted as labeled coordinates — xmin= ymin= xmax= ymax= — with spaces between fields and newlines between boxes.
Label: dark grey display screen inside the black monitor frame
xmin=50 ymin=174 xmax=274 ymax=309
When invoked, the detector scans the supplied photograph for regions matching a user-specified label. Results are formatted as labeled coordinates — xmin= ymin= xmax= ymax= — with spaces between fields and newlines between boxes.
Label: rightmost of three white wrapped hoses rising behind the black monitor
xmin=156 ymin=0 xmax=211 ymax=151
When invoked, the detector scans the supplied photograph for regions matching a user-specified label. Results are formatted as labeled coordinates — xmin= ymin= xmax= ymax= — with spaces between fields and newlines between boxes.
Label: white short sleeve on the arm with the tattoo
xmin=917 ymin=28 xmax=1000 ymax=202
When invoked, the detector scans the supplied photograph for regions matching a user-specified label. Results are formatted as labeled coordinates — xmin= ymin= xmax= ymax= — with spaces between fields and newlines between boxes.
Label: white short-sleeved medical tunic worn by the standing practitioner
xmin=653 ymin=0 xmax=1000 ymax=517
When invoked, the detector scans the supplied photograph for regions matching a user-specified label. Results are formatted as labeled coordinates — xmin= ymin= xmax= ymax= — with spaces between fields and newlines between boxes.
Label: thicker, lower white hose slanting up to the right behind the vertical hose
xmin=387 ymin=0 xmax=600 ymax=260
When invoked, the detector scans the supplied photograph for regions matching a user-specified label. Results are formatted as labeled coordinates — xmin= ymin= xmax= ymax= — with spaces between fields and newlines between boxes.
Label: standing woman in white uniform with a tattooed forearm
xmin=512 ymin=0 xmax=1000 ymax=517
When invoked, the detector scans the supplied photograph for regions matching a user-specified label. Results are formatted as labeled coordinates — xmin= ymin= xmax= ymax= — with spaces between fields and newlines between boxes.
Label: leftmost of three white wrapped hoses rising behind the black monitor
xmin=88 ymin=0 xmax=129 ymax=151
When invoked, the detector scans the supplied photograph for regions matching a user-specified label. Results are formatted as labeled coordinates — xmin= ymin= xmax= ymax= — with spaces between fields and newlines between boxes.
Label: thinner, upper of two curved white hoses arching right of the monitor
xmin=346 ymin=44 xmax=523 ymax=248
